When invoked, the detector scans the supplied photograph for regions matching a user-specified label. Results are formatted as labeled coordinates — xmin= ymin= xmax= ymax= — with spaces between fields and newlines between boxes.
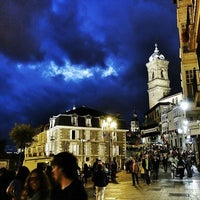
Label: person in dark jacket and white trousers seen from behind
xmin=92 ymin=164 xmax=108 ymax=200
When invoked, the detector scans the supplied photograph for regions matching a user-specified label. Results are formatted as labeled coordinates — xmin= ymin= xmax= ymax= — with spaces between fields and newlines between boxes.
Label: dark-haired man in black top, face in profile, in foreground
xmin=52 ymin=152 xmax=88 ymax=200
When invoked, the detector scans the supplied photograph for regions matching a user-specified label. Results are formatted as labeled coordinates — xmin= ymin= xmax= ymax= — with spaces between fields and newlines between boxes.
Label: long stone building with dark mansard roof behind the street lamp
xmin=25 ymin=106 xmax=127 ymax=168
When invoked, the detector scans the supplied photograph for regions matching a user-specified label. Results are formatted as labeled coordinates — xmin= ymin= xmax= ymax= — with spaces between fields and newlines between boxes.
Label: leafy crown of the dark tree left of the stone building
xmin=10 ymin=124 xmax=35 ymax=150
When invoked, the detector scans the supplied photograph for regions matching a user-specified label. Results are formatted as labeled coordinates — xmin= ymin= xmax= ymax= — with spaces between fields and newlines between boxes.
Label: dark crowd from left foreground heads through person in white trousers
xmin=0 ymin=152 xmax=117 ymax=200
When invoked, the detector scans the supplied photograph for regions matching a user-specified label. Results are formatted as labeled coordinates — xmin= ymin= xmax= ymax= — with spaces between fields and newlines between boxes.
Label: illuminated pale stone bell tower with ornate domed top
xmin=146 ymin=44 xmax=171 ymax=109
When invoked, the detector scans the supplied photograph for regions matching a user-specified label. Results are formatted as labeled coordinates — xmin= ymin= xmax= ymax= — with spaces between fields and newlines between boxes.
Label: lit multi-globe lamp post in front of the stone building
xmin=102 ymin=117 xmax=117 ymax=179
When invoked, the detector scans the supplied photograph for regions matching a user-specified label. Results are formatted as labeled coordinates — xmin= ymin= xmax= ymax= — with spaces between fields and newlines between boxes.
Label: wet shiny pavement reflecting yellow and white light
xmin=85 ymin=168 xmax=200 ymax=200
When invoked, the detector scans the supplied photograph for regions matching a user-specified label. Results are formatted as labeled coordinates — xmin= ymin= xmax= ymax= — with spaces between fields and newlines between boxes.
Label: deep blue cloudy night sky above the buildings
xmin=0 ymin=0 xmax=181 ymax=141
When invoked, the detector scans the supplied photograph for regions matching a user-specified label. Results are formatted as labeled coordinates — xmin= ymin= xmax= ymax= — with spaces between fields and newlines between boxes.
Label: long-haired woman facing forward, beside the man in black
xmin=21 ymin=168 xmax=50 ymax=200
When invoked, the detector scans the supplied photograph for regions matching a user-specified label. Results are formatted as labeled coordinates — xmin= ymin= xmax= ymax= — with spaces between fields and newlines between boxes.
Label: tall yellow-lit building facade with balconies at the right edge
xmin=174 ymin=0 xmax=200 ymax=164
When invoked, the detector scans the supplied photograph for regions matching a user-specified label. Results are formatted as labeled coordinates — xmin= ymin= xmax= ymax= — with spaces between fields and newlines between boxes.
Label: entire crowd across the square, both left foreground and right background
xmin=0 ymin=149 xmax=195 ymax=200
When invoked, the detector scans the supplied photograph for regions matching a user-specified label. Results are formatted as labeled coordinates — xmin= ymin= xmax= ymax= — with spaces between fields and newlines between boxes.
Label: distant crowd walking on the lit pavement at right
xmin=125 ymin=145 xmax=195 ymax=186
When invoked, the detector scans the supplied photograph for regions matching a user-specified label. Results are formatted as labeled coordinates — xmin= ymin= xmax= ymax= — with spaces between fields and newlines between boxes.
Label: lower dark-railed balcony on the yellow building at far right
xmin=193 ymin=69 xmax=200 ymax=107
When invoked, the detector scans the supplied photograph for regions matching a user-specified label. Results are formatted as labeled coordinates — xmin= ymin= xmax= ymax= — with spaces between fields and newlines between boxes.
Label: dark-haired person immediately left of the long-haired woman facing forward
xmin=6 ymin=166 xmax=30 ymax=200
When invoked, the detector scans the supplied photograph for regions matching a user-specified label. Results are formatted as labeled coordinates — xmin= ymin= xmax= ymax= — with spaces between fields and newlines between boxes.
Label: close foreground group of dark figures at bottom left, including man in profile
xmin=0 ymin=152 xmax=88 ymax=200
